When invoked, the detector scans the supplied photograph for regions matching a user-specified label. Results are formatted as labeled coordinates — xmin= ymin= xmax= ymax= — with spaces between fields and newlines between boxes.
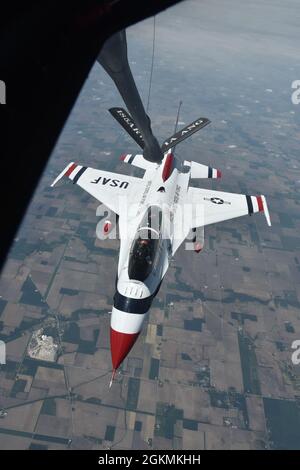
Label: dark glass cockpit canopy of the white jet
xmin=128 ymin=206 xmax=162 ymax=281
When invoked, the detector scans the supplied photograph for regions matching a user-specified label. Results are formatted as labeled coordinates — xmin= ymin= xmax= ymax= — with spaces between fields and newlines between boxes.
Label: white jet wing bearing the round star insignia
xmin=186 ymin=187 xmax=271 ymax=227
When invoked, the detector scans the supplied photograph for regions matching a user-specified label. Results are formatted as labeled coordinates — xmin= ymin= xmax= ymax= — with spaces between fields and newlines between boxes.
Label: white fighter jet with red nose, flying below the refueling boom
xmin=52 ymin=108 xmax=271 ymax=385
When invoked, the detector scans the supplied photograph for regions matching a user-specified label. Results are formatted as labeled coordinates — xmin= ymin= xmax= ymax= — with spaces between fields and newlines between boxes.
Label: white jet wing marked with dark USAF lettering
xmin=51 ymin=162 xmax=145 ymax=214
